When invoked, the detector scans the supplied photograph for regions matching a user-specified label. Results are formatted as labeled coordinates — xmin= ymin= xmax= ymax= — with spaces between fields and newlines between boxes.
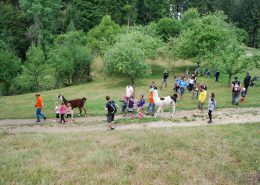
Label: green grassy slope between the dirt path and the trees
xmin=0 ymin=60 xmax=260 ymax=119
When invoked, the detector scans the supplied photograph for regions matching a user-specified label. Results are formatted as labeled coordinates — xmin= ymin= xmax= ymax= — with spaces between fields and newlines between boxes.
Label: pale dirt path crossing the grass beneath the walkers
xmin=0 ymin=108 xmax=260 ymax=133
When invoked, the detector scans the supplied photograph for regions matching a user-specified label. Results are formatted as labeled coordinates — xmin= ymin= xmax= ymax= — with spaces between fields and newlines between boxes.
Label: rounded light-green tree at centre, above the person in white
xmin=104 ymin=31 xmax=162 ymax=84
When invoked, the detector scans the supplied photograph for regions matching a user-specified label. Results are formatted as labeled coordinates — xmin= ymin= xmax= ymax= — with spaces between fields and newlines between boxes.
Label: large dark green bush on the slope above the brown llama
xmin=49 ymin=31 xmax=93 ymax=85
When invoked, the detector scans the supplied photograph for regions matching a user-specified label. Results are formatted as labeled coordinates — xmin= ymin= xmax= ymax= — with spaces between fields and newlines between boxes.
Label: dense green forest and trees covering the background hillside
xmin=0 ymin=0 xmax=260 ymax=94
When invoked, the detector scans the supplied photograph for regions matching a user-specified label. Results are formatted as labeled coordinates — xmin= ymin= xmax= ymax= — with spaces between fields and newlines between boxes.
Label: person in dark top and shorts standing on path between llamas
xmin=105 ymin=96 xmax=116 ymax=131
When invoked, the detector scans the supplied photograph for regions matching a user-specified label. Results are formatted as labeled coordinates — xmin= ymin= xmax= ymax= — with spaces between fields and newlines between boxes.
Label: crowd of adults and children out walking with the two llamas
xmin=35 ymin=70 xmax=254 ymax=130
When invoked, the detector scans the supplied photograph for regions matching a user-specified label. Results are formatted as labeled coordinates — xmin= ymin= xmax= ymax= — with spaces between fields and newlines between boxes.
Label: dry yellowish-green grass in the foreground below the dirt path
xmin=0 ymin=123 xmax=260 ymax=185
